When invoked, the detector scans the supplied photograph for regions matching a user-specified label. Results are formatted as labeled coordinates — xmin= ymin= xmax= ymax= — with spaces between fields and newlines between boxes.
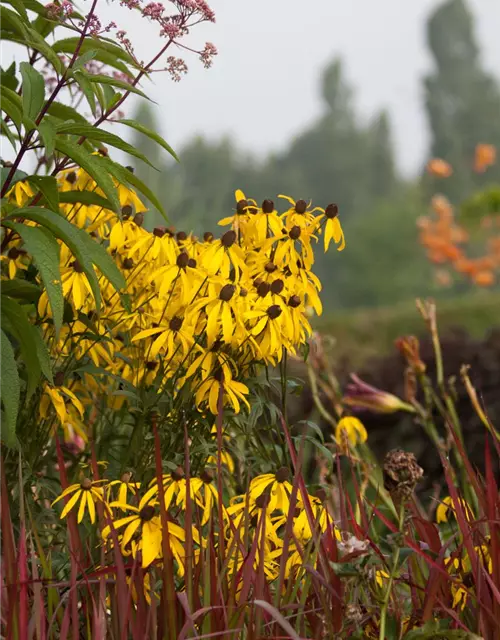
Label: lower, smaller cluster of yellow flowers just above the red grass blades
xmin=54 ymin=467 xmax=341 ymax=581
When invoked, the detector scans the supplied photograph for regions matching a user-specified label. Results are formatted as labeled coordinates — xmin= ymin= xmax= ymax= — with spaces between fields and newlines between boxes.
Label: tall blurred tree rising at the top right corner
xmin=424 ymin=0 xmax=500 ymax=202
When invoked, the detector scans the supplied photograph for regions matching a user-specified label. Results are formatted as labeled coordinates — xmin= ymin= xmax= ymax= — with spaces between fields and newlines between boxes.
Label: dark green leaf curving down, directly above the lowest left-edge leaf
xmin=0 ymin=295 xmax=41 ymax=399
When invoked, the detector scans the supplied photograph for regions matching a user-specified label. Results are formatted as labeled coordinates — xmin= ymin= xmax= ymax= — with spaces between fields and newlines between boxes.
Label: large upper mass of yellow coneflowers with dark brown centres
xmin=7 ymin=169 xmax=344 ymax=439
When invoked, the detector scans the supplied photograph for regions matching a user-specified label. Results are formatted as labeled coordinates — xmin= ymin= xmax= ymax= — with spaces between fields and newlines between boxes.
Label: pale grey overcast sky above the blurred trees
xmin=94 ymin=0 xmax=500 ymax=173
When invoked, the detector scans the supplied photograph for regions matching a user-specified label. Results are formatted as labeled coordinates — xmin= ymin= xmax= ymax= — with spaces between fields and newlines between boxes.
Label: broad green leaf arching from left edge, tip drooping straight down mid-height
xmin=3 ymin=222 xmax=64 ymax=335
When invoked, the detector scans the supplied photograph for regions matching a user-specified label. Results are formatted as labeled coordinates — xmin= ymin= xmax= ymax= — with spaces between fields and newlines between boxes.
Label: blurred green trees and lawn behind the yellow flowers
xmin=129 ymin=0 xmax=500 ymax=355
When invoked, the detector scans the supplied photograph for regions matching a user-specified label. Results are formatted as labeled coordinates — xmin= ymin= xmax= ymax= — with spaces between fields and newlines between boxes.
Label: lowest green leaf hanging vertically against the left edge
xmin=0 ymin=329 xmax=21 ymax=447
